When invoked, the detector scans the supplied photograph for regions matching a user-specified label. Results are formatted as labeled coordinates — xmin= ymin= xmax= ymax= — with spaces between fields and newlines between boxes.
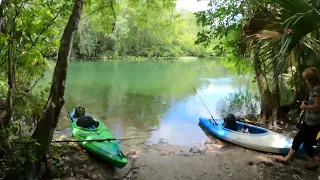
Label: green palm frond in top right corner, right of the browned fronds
xmin=266 ymin=0 xmax=320 ymax=76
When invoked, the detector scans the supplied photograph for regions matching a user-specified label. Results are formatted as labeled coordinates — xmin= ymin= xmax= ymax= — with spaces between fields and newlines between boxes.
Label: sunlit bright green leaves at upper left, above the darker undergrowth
xmin=0 ymin=0 xmax=72 ymax=95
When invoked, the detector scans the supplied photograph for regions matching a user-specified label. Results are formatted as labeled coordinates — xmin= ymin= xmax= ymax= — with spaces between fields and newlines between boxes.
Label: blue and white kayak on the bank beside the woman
xmin=199 ymin=117 xmax=306 ymax=156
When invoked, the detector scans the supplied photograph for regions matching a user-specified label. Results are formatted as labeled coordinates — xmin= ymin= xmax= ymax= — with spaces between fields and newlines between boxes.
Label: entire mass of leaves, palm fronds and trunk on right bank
xmin=196 ymin=0 xmax=320 ymax=124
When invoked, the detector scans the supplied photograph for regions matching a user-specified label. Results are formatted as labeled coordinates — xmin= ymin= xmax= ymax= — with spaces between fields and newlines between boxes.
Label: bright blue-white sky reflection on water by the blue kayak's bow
xmin=148 ymin=77 xmax=238 ymax=145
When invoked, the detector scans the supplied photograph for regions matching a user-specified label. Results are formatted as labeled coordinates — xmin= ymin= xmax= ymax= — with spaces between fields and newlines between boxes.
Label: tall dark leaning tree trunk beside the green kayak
xmin=6 ymin=0 xmax=84 ymax=179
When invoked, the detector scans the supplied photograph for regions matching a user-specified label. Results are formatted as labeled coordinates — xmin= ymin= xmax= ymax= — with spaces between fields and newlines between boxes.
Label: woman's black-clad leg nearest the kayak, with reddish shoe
xmin=276 ymin=123 xmax=308 ymax=163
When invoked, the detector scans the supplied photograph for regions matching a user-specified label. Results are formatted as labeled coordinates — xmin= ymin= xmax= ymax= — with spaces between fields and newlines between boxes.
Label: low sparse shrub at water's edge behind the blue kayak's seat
xmin=217 ymin=90 xmax=260 ymax=117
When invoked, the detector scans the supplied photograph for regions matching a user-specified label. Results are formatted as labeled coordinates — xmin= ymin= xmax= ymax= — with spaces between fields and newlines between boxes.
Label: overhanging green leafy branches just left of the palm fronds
xmin=195 ymin=0 xmax=252 ymax=74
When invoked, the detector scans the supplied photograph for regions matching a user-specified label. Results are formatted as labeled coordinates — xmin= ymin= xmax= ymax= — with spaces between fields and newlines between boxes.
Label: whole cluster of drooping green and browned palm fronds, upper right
xmin=242 ymin=0 xmax=320 ymax=77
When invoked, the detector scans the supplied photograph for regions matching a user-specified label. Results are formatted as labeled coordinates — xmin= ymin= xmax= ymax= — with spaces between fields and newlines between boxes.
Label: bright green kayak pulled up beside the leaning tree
xmin=69 ymin=109 xmax=128 ymax=168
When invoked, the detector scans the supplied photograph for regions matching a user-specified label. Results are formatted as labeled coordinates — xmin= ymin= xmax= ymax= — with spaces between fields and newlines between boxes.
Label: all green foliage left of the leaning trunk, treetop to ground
xmin=0 ymin=0 xmax=73 ymax=174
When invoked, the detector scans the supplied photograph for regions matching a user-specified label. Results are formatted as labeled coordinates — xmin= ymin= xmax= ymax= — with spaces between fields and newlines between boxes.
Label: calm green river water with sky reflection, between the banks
xmin=38 ymin=59 xmax=256 ymax=145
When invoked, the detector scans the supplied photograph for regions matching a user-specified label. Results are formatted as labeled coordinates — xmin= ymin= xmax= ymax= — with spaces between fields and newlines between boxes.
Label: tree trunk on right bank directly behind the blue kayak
xmin=252 ymin=47 xmax=279 ymax=123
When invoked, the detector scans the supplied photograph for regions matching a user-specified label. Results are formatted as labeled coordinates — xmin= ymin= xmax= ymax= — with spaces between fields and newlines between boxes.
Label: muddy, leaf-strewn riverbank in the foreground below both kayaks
xmin=44 ymin=135 xmax=319 ymax=180
